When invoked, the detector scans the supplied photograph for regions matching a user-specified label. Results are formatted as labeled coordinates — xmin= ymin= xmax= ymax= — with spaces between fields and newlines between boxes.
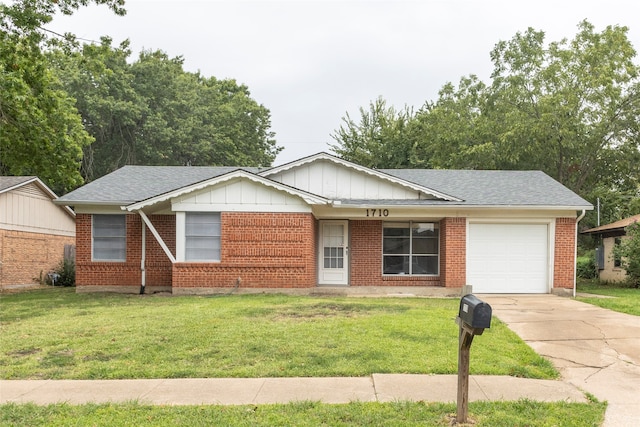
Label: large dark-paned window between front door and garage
xmin=382 ymin=222 xmax=440 ymax=275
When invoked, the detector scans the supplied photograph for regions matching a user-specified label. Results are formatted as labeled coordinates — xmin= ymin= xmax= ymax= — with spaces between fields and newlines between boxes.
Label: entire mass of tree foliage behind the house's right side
xmin=333 ymin=21 xmax=640 ymax=221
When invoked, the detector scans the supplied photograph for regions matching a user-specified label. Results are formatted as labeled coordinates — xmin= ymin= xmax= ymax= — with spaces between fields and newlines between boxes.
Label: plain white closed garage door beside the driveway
xmin=467 ymin=223 xmax=549 ymax=293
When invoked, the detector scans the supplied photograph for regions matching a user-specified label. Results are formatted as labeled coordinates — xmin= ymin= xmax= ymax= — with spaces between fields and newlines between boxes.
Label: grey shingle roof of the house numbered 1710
xmin=56 ymin=153 xmax=593 ymax=210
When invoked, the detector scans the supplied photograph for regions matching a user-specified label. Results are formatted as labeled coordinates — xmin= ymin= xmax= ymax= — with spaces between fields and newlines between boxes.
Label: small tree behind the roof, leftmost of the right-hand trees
xmin=330 ymin=97 xmax=413 ymax=168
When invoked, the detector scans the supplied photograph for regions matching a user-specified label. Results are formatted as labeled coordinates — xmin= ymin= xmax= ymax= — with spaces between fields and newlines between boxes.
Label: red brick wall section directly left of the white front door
xmin=173 ymin=212 xmax=317 ymax=288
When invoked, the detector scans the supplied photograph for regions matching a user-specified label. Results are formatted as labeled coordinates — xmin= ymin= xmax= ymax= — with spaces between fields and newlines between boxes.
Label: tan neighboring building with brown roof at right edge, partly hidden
xmin=582 ymin=214 xmax=640 ymax=282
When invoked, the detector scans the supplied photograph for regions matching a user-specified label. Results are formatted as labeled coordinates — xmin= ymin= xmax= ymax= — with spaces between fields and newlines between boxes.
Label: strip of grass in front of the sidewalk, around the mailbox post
xmin=0 ymin=400 xmax=606 ymax=427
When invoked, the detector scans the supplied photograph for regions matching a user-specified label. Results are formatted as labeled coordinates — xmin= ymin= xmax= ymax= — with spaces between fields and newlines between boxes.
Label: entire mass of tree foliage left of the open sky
xmin=0 ymin=0 xmax=281 ymax=193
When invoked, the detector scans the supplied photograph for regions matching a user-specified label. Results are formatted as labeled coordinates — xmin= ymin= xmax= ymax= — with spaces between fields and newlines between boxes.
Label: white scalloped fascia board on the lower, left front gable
xmin=123 ymin=169 xmax=330 ymax=212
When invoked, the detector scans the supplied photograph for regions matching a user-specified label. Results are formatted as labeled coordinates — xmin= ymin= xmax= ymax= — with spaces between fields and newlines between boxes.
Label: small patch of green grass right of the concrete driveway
xmin=576 ymin=279 xmax=640 ymax=316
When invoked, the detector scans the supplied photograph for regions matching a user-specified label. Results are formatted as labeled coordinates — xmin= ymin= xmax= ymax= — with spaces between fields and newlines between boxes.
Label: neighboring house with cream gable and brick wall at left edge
xmin=0 ymin=176 xmax=76 ymax=287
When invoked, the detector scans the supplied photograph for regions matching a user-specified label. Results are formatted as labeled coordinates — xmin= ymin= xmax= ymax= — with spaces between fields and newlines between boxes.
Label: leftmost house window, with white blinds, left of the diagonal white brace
xmin=92 ymin=215 xmax=127 ymax=261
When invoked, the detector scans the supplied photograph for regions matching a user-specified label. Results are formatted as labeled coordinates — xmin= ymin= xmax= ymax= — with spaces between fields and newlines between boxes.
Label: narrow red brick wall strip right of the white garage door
xmin=553 ymin=218 xmax=576 ymax=289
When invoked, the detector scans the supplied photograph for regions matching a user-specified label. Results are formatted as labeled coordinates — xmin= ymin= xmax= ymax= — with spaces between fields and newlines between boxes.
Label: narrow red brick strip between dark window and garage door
xmin=440 ymin=218 xmax=467 ymax=288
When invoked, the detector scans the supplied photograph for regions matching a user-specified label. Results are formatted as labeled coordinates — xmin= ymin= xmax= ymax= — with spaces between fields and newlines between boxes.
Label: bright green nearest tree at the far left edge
xmin=0 ymin=0 xmax=124 ymax=193
